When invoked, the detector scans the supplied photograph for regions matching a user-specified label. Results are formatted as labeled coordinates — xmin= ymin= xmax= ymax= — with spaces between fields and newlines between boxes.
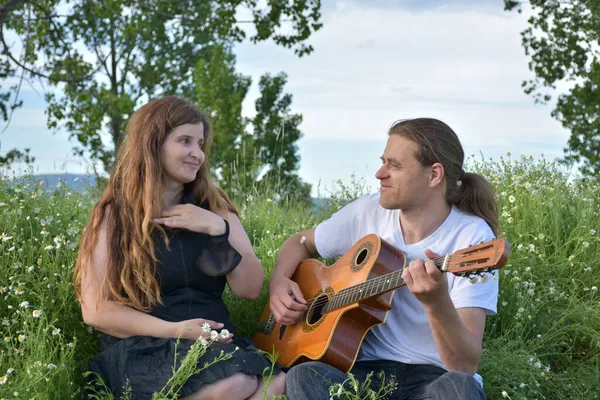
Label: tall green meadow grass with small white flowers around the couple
xmin=0 ymin=158 xmax=600 ymax=400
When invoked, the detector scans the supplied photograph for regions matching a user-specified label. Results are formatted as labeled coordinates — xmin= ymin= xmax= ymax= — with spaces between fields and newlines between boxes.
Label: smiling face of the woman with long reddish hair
xmin=161 ymin=123 xmax=205 ymax=184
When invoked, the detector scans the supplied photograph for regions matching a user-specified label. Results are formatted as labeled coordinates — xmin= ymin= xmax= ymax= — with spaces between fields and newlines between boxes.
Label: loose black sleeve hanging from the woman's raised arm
xmin=196 ymin=219 xmax=242 ymax=276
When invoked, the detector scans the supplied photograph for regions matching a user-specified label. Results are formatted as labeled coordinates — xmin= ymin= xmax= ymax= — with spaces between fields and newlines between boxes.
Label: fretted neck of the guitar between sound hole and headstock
xmin=322 ymin=256 xmax=449 ymax=313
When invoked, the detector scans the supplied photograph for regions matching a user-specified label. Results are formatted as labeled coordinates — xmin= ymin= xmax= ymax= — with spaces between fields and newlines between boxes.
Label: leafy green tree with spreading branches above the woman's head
xmin=0 ymin=0 xmax=321 ymax=170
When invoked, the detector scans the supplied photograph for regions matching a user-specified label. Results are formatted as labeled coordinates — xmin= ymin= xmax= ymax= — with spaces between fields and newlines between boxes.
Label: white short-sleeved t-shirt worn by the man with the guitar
xmin=315 ymin=193 xmax=498 ymax=383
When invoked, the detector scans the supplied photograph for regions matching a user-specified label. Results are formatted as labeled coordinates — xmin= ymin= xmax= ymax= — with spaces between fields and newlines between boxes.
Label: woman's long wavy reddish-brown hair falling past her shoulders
xmin=73 ymin=96 xmax=237 ymax=312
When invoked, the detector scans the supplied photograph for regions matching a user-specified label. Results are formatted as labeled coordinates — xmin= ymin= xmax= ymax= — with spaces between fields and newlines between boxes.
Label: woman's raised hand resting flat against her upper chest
xmin=154 ymin=204 xmax=226 ymax=236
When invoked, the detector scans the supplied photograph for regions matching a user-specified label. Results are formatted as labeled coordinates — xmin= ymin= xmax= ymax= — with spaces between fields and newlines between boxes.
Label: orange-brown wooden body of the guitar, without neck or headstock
xmin=253 ymin=234 xmax=406 ymax=372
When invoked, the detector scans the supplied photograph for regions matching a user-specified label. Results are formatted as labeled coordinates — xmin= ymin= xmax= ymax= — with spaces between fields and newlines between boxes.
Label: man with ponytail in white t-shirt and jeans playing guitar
xmin=269 ymin=118 xmax=498 ymax=400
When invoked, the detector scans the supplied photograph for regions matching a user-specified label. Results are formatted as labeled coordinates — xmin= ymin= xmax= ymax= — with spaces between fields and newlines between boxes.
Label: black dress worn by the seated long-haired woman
xmin=90 ymin=196 xmax=279 ymax=400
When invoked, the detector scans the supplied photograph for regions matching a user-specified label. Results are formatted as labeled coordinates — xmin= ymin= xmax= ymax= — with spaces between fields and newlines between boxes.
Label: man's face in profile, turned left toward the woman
xmin=375 ymin=135 xmax=431 ymax=211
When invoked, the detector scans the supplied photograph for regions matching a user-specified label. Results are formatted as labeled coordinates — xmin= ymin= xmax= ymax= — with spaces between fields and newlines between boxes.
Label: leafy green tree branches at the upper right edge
xmin=504 ymin=0 xmax=600 ymax=175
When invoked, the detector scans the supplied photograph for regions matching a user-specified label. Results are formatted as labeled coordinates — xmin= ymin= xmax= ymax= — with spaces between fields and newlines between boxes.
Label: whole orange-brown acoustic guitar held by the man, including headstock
xmin=252 ymin=234 xmax=510 ymax=372
